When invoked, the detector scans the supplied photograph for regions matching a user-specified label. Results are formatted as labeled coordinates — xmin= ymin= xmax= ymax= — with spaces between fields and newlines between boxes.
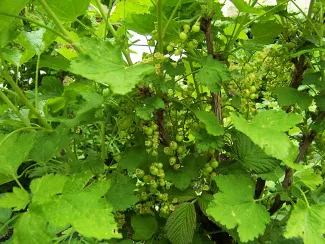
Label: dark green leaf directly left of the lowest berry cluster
xmin=106 ymin=173 xmax=138 ymax=211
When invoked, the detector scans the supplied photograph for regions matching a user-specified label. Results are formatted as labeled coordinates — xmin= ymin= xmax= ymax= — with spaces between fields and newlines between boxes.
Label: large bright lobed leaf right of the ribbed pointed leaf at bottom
xmin=207 ymin=175 xmax=270 ymax=242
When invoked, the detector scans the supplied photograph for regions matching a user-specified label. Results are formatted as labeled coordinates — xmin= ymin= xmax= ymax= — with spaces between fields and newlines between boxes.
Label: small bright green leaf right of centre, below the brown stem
xmin=195 ymin=111 xmax=224 ymax=136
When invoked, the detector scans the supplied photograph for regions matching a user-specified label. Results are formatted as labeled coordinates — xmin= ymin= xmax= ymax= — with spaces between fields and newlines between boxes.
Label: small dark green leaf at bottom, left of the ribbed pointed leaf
xmin=131 ymin=215 xmax=158 ymax=241
